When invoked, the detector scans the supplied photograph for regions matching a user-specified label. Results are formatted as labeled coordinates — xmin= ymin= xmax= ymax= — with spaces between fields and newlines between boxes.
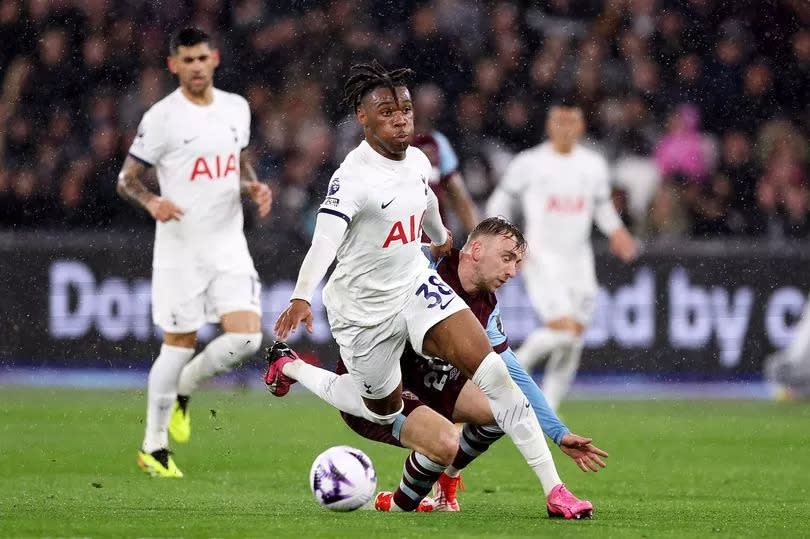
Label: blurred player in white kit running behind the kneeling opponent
xmin=486 ymin=104 xmax=637 ymax=410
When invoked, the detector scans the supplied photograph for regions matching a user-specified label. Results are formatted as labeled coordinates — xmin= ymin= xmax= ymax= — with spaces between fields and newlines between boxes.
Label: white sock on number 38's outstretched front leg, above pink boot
xmin=472 ymin=352 xmax=562 ymax=496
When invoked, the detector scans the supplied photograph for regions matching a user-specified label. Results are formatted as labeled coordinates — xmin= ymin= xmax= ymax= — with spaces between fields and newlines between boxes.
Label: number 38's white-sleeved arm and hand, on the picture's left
xmin=273 ymin=213 xmax=347 ymax=341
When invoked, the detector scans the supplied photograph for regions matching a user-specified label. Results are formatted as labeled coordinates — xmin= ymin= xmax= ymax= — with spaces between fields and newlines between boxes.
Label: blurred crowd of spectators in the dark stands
xmin=0 ymin=0 xmax=810 ymax=240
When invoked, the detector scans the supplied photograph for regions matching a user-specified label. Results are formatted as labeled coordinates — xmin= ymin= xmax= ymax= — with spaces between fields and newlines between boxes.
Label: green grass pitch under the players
xmin=0 ymin=388 xmax=810 ymax=539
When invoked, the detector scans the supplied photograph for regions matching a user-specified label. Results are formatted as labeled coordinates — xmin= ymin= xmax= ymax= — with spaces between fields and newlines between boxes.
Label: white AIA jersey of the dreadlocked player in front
xmin=318 ymin=141 xmax=435 ymax=326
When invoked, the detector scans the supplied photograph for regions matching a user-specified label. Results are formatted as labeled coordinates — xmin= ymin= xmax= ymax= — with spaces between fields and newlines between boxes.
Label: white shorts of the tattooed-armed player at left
xmin=152 ymin=267 xmax=262 ymax=333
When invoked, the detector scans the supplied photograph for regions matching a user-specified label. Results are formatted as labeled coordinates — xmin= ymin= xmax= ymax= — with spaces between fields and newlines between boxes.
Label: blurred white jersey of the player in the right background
xmin=487 ymin=142 xmax=621 ymax=258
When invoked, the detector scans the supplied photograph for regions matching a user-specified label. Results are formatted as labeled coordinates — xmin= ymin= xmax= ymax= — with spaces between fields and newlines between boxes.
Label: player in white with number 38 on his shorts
xmin=275 ymin=61 xmax=572 ymax=512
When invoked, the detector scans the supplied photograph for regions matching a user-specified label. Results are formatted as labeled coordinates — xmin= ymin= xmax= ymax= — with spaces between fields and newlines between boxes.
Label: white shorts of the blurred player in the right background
xmin=523 ymin=252 xmax=599 ymax=326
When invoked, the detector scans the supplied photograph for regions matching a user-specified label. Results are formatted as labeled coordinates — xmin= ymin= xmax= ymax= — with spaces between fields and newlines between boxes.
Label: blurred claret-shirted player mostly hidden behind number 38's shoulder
xmin=413 ymin=84 xmax=479 ymax=236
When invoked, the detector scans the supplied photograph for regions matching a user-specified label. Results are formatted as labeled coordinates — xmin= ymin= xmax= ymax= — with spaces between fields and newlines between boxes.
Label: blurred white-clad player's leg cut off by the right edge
xmin=765 ymin=298 xmax=810 ymax=400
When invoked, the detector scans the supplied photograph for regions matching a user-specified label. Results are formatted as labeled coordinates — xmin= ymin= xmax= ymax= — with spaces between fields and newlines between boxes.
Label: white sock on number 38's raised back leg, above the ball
xmin=281 ymin=359 xmax=362 ymax=419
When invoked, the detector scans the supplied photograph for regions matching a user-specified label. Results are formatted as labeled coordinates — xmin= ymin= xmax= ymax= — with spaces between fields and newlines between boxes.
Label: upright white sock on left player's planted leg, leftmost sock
xmin=141 ymin=344 xmax=194 ymax=453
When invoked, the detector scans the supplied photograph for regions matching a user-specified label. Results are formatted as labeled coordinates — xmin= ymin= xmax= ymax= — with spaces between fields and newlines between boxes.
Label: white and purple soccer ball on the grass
xmin=309 ymin=445 xmax=377 ymax=511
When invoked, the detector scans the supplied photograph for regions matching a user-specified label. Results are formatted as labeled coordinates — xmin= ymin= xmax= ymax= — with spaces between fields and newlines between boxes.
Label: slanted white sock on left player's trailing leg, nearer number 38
xmin=177 ymin=333 xmax=262 ymax=397
